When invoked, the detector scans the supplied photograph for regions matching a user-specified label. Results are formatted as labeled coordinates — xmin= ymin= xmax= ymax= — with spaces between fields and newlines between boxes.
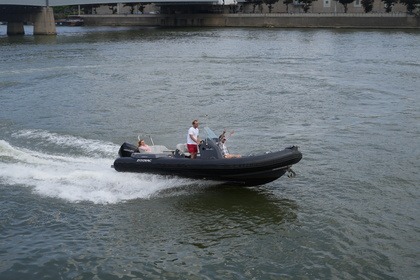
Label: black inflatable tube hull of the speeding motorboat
xmin=114 ymin=147 xmax=302 ymax=186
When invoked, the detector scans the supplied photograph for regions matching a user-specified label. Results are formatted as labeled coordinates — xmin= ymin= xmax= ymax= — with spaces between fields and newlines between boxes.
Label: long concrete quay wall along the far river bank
xmin=82 ymin=13 xmax=420 ymax=29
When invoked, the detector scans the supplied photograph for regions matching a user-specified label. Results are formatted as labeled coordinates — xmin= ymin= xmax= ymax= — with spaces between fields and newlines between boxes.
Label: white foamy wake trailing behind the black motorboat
xmin=0 ymin=130 xmax=215 ymax=204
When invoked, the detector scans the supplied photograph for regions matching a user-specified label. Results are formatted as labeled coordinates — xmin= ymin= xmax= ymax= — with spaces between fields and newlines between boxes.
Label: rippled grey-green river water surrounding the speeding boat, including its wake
xmin=0 ymin=26 xmax=420 ymax=279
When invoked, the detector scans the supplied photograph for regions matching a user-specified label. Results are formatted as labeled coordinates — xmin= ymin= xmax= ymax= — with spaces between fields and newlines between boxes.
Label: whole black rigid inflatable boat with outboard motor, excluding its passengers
xmin=113 ymin=127 xmax=302 ymax=186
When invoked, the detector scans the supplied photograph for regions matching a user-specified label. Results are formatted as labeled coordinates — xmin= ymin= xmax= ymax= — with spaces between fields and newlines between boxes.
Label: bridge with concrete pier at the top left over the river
xmin=0 ymin=0 xmax=236 ymax=35
